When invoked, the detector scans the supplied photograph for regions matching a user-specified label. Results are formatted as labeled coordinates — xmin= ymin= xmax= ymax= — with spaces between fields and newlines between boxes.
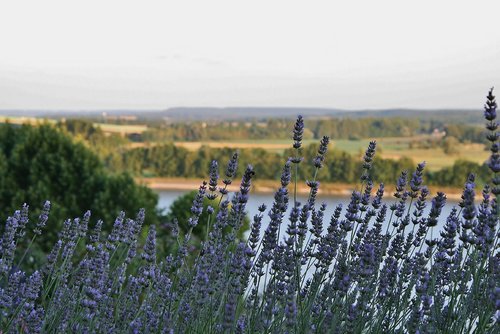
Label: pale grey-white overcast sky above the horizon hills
xmin=0 ymin=0 xmax=500 ymax=110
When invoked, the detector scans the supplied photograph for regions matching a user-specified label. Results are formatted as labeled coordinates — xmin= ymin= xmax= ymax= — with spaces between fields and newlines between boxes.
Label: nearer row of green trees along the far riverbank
xmin=122 ymin=143 xmax=488 ymax=187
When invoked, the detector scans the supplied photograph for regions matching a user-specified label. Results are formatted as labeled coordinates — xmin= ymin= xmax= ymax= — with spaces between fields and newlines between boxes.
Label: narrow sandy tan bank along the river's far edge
xmin=136 ymin=177 xmax=462 ymax=200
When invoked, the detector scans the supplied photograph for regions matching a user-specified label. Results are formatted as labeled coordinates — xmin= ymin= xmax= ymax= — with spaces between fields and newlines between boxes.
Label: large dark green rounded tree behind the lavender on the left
xmin=0 ymin=125 xmax=160 ymax=250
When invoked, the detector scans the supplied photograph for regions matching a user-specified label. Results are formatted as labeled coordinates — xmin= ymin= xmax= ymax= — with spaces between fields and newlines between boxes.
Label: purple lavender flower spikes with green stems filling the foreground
xmin=0 ymin=90 xmax=500 ymax=333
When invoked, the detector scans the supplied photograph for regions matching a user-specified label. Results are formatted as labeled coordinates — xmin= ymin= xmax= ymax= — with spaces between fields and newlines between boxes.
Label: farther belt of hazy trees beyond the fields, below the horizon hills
xmin=136 ymin=118 xmax=485 ymax=143
